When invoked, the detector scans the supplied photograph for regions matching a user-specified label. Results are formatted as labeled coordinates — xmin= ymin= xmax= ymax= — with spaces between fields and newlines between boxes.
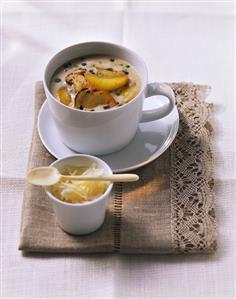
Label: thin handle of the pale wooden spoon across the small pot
xmin=61 ymin=173 xmax=139 ymax=182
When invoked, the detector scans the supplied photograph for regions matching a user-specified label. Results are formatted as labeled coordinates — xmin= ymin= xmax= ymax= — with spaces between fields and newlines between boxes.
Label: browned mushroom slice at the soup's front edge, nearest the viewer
xmin=75 ymin=89 xmax=117 ymax=109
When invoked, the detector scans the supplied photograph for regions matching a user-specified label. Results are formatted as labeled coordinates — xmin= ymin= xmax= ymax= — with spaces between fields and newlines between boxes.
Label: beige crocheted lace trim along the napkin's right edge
xmin=170 ymin=83 xmax=216 ymax=252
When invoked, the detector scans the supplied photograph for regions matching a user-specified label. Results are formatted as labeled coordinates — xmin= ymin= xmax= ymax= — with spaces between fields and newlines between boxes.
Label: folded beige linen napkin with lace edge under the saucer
xmin=19 ymin=82 xmax=216 ymax=254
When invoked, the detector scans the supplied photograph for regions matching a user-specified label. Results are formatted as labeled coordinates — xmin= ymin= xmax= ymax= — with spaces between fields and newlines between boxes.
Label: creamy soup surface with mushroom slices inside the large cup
xmin=50 ymin=56 xmax=141 ymax=111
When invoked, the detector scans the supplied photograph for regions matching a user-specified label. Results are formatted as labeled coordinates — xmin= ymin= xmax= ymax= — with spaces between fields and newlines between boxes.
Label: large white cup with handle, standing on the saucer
xmin=43 ymin=42 xmax=175 ymax=155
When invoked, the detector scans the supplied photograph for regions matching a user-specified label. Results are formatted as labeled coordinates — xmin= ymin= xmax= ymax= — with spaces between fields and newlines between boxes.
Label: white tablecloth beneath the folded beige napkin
xmin=1 ymin=1 xmax=236 ymax=298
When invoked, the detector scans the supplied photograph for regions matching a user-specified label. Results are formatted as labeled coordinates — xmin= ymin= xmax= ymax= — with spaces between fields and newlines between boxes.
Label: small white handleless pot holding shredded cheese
xmin=46 ymin=155 xmax=113 ymax=235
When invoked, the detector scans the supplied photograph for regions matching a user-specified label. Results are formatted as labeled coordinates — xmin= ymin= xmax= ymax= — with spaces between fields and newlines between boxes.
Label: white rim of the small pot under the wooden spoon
xmin=45 ymin=154 xmax=113 ymax=207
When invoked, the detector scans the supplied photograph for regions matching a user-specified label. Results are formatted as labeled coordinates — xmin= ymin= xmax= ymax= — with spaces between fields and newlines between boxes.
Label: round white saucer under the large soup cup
xmin=38 ymin=97 xmax=179 ymax=173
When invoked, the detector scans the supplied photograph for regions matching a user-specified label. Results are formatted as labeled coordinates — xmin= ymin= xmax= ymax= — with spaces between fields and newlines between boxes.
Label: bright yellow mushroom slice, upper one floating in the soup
xmin=84 ymin=69 xmax=129 ymax=91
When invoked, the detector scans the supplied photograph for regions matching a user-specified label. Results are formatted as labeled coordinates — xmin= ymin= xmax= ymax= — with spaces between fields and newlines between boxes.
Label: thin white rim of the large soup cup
xmin=43 ymin=41 xmax=148 ymax=114
